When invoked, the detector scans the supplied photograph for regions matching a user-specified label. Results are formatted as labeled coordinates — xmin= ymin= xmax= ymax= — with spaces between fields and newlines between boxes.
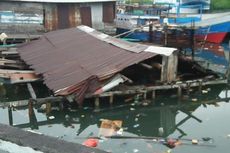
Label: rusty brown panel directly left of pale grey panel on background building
xmin=80 ymin=6 xmax=92 ymax=27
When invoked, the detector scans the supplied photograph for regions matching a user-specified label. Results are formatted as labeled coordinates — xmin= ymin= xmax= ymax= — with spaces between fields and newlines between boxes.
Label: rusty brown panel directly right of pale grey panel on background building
xmin=103 ymin=2 xmax=115 ymax=23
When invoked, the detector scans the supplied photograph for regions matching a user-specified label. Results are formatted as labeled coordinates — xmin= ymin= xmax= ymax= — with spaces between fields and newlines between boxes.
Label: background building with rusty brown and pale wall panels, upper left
xmin=0 ymin=0 xmax=116 ymax=33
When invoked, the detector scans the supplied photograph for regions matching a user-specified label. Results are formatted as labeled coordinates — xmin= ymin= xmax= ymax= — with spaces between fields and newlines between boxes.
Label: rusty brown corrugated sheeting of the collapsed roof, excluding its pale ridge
xmin=18 ymin=28 xmax=176 ymax=103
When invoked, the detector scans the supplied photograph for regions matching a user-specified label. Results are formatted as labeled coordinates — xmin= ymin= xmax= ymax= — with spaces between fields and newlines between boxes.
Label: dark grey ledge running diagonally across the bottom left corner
xmin=0 ymin=124 xmax=106 ymax=153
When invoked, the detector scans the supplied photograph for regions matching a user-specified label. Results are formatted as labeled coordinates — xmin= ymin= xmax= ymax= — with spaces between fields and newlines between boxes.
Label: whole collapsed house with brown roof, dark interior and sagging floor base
xmin=17 ymin=26 xmax=224 ymax=104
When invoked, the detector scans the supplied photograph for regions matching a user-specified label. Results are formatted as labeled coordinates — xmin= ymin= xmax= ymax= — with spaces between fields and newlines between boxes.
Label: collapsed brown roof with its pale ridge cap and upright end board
xmin=18 ymin=26 xmax=177 ymax=103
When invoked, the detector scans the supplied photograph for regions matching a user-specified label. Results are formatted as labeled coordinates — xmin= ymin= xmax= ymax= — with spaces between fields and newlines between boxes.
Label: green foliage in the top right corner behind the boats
xmin=211 ymin=0 xmax=230 ymax=10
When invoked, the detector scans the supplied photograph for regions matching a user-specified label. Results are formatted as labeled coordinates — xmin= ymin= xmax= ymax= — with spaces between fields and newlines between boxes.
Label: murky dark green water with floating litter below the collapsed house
xmin=0 ymin=86 xmax=230 ymax=153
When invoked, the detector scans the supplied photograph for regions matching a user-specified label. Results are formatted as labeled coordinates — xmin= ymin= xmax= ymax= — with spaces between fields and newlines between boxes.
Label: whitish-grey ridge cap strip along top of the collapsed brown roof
xmin=77 ymin=25 xmax=177 ymax=56
